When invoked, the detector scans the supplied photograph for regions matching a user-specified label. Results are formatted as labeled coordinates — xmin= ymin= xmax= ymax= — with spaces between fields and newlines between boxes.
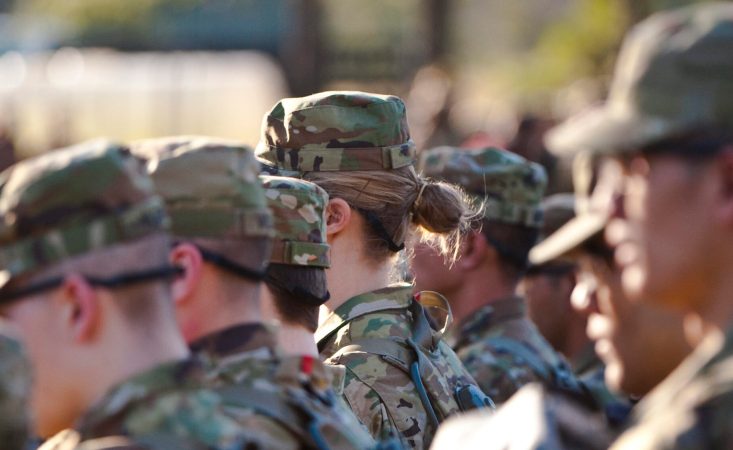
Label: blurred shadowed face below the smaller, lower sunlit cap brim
xmin=573 ymin=255 xmax=690 ymax=395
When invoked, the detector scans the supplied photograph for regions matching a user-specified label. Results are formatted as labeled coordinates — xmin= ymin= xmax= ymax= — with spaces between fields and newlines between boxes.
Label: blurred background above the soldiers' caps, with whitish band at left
xmin=0 ymin=0 xmax=724 ymax=188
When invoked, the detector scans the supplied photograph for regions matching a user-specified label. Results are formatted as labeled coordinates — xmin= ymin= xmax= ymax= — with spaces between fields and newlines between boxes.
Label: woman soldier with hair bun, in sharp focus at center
xmin=257 ymin=92 xmax=484 ymax=448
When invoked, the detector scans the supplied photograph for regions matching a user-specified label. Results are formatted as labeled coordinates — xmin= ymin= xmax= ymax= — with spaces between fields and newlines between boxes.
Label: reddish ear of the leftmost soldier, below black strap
xmin=57 ymin=274 xmax=102 ymax=342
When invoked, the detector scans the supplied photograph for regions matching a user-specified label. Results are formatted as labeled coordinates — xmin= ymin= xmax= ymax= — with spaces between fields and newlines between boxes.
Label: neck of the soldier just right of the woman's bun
xmin=445 ymin=268 xmax=517 ymax=323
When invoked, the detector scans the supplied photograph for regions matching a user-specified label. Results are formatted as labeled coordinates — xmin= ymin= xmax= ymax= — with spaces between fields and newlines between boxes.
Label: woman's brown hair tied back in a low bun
xmin=303 ymin=167 xmax=476 ymax=262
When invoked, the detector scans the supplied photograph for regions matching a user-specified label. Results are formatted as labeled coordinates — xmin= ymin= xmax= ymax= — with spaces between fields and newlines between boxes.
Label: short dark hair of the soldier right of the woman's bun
xmin=481 ymin=219 xmax=540 ymax=281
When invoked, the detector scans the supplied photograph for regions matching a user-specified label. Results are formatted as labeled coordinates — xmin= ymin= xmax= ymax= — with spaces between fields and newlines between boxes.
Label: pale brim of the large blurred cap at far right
xmin=545 ymin=105 xmax=680 ymax=156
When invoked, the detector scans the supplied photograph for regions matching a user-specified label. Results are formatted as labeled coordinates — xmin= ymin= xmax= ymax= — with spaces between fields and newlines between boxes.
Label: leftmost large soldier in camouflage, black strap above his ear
xmin=0 ymin=141 xmax=260 ymax=449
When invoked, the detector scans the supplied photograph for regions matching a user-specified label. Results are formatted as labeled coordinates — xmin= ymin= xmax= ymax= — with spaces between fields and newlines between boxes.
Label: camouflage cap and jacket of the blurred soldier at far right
xmin=536 ymin=3 xmax=733 ymax=449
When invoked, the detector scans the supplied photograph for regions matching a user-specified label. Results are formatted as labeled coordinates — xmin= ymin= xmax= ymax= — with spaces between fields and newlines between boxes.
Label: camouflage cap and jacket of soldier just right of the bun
xmin=420 ymin=147 xmax=578 ymax=402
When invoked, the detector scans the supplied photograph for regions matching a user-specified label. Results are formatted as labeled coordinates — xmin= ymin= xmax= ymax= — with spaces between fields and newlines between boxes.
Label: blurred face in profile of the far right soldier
xmin=606 ymin=155 xmax=716 ymax=309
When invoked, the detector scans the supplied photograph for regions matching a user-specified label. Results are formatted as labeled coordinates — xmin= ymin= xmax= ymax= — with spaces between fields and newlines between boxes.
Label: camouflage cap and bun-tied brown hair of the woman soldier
xmin=257 ymin=91 xmax=471 ymax=262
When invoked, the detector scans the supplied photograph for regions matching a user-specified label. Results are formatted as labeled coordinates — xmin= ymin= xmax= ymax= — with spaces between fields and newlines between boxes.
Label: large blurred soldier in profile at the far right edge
xmin=548 ymin=3 xmax=733 ymax=449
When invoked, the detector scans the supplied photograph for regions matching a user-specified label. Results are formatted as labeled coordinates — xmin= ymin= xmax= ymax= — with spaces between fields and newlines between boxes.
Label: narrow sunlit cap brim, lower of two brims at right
xmin=529 ymin=214 xmax=608 ymax=265
